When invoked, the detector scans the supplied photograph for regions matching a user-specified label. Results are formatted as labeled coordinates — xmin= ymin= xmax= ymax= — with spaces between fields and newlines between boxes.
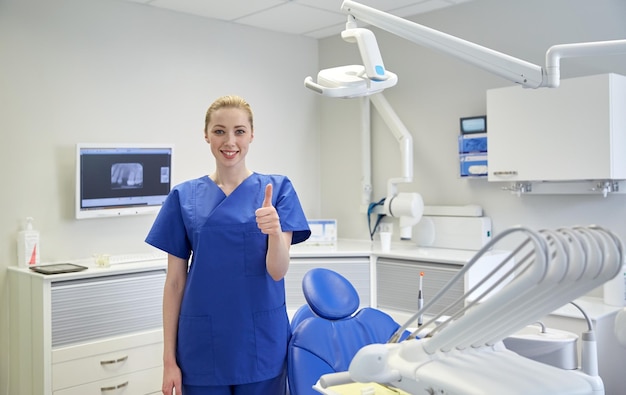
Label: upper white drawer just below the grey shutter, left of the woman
xmin=52 ymin=343 xmax=163 ymax=394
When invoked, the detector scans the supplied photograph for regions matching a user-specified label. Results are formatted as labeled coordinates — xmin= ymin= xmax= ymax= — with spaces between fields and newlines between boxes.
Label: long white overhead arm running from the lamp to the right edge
xmin=341 ymin=0 xmax=626 ymax=88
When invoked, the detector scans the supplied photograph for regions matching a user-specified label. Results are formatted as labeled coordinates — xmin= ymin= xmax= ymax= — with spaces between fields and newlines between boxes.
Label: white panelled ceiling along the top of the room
xmin=120 ymin=0 xmax=470 ymax=38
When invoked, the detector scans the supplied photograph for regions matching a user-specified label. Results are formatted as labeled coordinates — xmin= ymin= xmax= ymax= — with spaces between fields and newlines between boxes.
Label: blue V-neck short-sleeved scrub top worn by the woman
xmin=146 ymin=173 xmax=311 ymax=386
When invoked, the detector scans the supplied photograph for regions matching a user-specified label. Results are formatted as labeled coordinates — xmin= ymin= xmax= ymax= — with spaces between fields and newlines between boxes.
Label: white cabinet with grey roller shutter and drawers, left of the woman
xmin=9 ymin=260 xmax=166 ymax=395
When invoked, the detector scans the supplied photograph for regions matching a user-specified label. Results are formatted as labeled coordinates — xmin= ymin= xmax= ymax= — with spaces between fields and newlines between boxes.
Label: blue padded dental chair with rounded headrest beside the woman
xmin=287 ymin=268 xmax=409 ymax=395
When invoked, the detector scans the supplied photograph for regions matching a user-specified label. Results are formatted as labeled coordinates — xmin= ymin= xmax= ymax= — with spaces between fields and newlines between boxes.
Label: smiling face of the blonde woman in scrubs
xmin=204 ymin=108 xmax=254 ymax=167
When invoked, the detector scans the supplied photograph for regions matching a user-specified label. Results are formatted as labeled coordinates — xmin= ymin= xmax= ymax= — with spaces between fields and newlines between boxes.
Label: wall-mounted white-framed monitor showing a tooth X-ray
xmin=76 ymin=143 xmax=174 ymax=219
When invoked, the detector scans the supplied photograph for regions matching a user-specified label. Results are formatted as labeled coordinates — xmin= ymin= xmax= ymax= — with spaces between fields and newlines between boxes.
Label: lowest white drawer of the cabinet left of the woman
xmin=52 ymin=367 xmax=163 ymax=395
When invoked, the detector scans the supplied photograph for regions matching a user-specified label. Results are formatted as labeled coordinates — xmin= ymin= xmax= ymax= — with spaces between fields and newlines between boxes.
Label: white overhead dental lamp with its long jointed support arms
xmin=304 ymin=0 xmax=626 ymax=240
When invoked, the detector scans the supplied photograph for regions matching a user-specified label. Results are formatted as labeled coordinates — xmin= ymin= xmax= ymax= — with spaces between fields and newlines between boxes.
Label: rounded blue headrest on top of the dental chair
xmin=302 ymin=268 xmax=360 ymax=320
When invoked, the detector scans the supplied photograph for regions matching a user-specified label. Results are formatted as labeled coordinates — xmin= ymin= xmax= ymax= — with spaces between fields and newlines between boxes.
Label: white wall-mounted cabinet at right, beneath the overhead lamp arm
xmin=487 ymin=74 xmax=626 ymax=193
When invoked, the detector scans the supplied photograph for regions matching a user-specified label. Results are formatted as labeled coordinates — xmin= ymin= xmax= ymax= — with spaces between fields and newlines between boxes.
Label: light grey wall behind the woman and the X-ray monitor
xmin=0 ymin=0 xmax=320 ymax=394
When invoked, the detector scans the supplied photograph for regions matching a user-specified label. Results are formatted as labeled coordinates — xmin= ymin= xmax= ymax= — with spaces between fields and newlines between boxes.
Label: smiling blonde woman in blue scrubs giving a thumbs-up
xmin=146 ymin=96 xmax=311 ymax=395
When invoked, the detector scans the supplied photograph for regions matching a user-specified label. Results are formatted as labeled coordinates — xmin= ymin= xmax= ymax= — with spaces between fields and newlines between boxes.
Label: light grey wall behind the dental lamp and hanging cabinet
xmin=320 ymin=0 xmax=626 ymax=243
